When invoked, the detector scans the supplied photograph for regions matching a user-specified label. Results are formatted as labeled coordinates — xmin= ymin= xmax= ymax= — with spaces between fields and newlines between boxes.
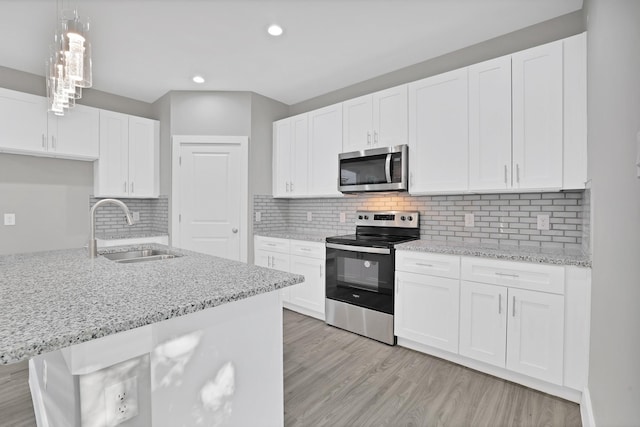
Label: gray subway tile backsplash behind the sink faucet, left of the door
xmin=89 ymin=196 xmax=169 ymax=235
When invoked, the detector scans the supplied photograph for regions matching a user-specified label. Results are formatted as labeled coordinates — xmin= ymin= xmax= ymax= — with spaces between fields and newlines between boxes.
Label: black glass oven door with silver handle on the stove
xmin=326 ymin=243 xmax=395 ymax=314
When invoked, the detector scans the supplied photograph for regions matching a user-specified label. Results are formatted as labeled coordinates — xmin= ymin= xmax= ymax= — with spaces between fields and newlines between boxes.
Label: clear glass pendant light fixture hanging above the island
xmin=46 ymin=1 xmax=93 ymax=116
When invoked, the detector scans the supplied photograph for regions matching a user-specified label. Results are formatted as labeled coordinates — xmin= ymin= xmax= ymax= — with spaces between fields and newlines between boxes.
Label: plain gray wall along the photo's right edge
xmin=586 ymin=0 xmax=640 ymax=426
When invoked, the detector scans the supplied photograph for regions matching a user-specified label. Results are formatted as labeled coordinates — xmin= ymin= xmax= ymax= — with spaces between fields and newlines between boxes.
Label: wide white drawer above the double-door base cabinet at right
xmin=461 ymin=257 xmax=564 ymax=294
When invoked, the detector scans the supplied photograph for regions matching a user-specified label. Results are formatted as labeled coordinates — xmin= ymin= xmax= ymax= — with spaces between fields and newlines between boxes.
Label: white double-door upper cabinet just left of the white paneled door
xmin=94 ymin=110 xmax=160 ymax=198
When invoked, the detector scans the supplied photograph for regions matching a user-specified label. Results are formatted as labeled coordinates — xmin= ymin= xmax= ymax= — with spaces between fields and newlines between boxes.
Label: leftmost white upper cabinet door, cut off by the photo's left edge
xmin=0 ymin=89 xmax=47 ymax=153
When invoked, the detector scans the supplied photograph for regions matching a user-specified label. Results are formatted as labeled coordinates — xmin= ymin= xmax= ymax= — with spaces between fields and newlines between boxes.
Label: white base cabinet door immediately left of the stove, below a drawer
xmin=290 ymin=255 xmax=325 ymax=319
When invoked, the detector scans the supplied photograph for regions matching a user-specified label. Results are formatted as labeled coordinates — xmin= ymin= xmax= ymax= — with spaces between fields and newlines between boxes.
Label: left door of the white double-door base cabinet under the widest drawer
xmin=460 ymin=281 xmax=507 ymax=368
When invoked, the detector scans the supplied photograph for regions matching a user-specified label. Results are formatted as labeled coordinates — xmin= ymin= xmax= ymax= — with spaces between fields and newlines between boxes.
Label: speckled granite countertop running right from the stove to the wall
xmin=396 ymin=240 xmax=591 ymax=267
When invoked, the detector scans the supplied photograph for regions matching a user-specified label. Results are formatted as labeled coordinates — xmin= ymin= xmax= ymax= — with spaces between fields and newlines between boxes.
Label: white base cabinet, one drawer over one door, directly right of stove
xmin=394 ymin=252 xmax=460 ymax=353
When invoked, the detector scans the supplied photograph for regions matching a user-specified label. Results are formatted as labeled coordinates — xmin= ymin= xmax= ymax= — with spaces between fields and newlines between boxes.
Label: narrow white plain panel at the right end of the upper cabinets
xmin=562 ymin=33 xmax=587 ymax=189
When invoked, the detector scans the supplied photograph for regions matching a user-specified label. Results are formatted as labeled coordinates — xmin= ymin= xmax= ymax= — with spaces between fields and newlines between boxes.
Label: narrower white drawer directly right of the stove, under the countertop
xmin=396 ymin=251 xmax=460 ymax=279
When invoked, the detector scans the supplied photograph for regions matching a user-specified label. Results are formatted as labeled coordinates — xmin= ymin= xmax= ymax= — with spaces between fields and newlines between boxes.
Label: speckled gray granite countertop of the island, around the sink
xmin=0 ymin=244 xmax=304 ymax=365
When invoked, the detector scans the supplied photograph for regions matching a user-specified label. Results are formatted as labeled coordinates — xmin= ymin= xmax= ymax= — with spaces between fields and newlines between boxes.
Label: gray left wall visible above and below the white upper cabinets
xmin=0 ymin=67 xmax=154 ymax=254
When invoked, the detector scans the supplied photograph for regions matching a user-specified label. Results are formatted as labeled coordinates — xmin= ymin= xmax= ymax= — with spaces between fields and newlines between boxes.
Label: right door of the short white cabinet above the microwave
xmin=372 ymin=85 xmax=409 ymax=147
